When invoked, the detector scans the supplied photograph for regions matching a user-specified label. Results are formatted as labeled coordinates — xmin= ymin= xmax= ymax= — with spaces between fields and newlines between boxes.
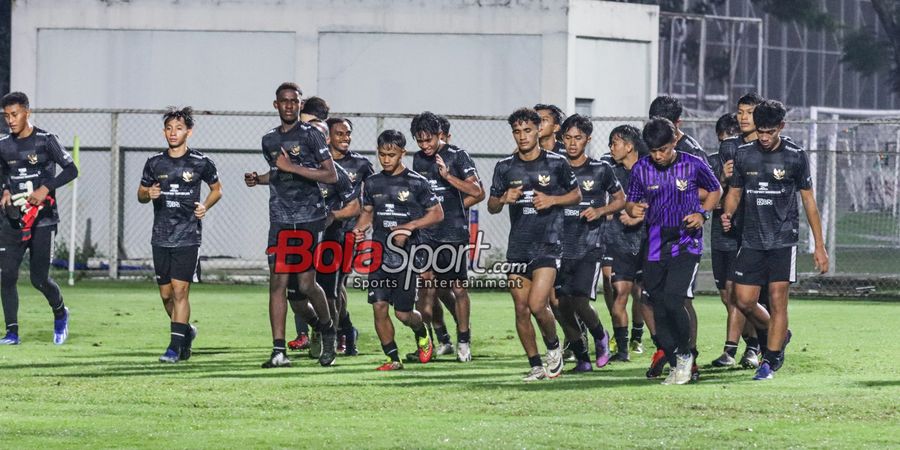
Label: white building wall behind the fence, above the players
xmin=11 ymin=0 xmax=659 ymax=116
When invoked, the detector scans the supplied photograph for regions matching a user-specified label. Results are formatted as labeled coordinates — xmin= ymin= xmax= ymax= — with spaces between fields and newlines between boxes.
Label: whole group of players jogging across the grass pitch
xmin=0 ymin=82 xmax=828 ymax=384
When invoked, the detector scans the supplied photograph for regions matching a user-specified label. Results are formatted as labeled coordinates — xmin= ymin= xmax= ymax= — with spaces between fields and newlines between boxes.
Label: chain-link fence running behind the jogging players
xmin=12 ymin=110 xmax=900 ymax=295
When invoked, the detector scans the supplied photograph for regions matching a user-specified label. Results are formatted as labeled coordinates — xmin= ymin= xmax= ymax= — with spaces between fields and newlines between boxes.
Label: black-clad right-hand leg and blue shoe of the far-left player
xmin=29 ymin=225 xmax=69 ymax=345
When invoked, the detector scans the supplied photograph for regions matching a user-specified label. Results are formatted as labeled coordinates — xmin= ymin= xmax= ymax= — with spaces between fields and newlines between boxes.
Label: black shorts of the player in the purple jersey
xmin=644 ymin=253 xmax=700 ymax=303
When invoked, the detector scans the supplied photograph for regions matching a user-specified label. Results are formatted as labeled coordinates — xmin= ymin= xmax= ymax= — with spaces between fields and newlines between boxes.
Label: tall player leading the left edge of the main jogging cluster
xmin=244 ymin=82 xmax=337 ymax=368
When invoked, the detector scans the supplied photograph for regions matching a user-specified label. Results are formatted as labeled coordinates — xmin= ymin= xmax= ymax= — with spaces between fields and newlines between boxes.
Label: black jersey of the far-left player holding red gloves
xmin=0 ymin=127 xmax=74 ymax=227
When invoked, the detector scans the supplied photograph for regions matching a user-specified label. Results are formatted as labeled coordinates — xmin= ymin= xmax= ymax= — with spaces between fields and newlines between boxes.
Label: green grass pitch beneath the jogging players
xmin=0 ymin=282 xmax=900 ymax=448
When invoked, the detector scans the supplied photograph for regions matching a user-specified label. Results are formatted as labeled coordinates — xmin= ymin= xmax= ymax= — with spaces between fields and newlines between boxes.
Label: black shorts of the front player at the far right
xmin=731 ymin=246 xmax=797 ymax=286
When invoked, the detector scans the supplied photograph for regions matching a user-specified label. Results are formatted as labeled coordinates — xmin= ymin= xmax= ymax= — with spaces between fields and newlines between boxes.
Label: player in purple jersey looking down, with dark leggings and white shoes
xmin=626 ymin=117 xmax=721 ymax=384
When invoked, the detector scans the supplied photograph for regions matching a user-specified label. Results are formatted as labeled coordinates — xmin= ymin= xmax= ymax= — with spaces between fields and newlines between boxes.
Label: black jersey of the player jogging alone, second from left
xmin=141 ymin=149 xmax=219 ymax=247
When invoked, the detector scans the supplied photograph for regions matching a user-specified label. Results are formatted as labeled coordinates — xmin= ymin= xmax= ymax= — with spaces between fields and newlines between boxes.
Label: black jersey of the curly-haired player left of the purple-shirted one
xmin=491 ymin=151 xmax=578 ymax=261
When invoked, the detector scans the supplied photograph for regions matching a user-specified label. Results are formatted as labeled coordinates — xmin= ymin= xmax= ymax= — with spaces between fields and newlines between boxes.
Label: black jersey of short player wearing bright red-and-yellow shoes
xmin=363 ymin=169 xmax=440 ymax=267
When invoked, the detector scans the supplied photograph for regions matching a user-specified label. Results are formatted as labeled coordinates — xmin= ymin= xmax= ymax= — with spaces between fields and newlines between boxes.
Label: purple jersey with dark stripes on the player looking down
xmin=627 ymin=152 xmax=719 ymax=261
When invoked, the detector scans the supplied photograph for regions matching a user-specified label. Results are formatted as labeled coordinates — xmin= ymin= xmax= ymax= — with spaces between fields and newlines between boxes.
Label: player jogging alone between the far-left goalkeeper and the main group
xmin=137 ymin=107 xmax=222 ymax=363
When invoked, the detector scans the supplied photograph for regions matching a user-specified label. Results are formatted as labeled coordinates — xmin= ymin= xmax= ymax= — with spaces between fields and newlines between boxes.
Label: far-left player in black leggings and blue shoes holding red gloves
xmin=0 ymin=92 xmax=78 ymax=345
